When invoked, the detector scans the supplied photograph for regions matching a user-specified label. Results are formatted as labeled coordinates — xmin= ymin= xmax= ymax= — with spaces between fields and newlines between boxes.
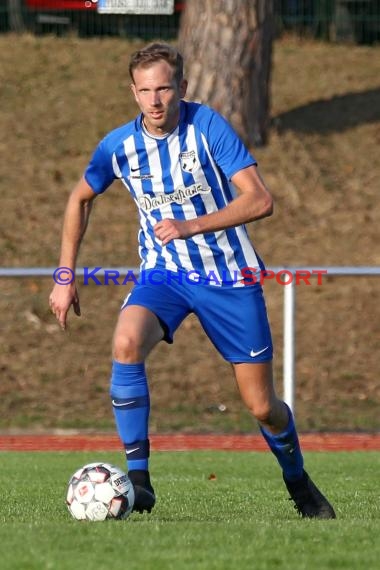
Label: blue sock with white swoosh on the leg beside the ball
xmin=110 ymin=360 xmax=150 ymax=471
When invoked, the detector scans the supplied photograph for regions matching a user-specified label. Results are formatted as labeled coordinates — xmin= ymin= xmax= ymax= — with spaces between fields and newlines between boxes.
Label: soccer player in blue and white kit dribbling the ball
xmin=49 ymin=43 xmax=335 ymax=519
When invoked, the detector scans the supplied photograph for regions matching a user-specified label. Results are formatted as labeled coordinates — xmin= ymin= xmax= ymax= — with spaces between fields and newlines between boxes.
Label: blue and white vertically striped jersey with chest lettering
xmin=85 ymin=101 xmax=263 ymax=286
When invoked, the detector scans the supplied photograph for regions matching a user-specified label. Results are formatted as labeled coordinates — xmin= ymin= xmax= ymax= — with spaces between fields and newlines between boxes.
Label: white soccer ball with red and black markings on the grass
xmin=66 ymin=463 xmax=135 ymax=521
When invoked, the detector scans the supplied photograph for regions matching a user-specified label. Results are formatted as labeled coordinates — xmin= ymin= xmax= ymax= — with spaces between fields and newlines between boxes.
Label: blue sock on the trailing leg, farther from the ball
xmin=260 ymin=406 xmax=303 ymax=481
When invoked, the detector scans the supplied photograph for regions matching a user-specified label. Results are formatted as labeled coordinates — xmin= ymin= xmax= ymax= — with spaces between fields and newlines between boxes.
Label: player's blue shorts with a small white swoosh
xmin=122 ymin=272 xmax=273 ymax=363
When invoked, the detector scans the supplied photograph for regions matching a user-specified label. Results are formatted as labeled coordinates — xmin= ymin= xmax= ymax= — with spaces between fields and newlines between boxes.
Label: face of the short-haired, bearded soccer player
xmin=131 ymin=60 xmax=187 ymax=136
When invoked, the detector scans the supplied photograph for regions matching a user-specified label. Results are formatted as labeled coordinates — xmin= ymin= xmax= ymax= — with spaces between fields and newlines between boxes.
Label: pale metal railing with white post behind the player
xmin=0 ymin=266 xmax=380 ymax=410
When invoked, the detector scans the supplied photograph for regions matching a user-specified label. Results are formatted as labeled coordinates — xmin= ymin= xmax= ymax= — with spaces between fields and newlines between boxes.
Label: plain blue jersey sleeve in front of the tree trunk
xmin=207 ymin=106 xmax=257 ymax=180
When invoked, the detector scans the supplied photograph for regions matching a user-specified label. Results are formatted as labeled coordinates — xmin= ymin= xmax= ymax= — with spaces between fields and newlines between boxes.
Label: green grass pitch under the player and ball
xmin=0 ymin=451 xmax=380 ymax=570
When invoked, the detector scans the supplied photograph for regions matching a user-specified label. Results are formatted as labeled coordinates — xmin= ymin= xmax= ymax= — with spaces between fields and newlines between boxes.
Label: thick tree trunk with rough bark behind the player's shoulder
xmin=178 ymin=0 xmax=274 ymax=147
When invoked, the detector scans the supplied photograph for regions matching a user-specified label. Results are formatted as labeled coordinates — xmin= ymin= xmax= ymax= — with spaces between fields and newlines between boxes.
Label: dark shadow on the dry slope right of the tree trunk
xmin=273 ymin=88 xmax=380 ymax=134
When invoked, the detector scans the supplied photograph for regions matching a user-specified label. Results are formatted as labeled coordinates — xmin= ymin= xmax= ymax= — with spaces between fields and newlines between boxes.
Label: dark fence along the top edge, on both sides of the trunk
xmin=0 ymin=0 xmax=380 ymax=44
